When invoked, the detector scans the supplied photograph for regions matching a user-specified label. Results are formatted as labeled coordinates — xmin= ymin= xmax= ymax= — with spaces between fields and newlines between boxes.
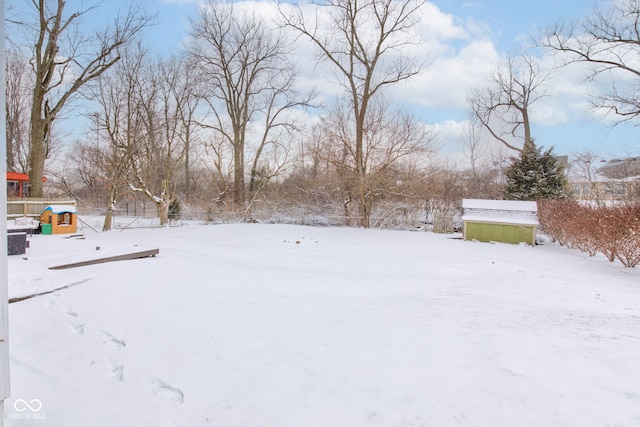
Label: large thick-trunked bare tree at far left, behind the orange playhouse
xmin=12 ymin=0 xmax=150 ymax=197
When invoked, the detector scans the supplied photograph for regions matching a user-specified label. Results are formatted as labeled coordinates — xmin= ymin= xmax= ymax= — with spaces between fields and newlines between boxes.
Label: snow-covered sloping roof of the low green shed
xmin=462 ymin=199 xmax=539 ymax=225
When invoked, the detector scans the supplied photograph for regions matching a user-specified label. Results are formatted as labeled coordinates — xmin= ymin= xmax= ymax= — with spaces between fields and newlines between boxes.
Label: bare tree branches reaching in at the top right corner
xmin=538 ymin=0 xmax=640 ymax=122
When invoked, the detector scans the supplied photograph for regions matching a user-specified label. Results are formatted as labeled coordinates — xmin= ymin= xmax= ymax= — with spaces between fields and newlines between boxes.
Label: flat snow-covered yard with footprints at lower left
xmin=5 ymin=224 xmax=640 ymax=427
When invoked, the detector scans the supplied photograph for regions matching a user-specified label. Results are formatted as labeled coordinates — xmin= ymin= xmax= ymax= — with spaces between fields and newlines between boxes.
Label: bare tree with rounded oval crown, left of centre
xmin=190 ymin=1 xmax=310 ymax=210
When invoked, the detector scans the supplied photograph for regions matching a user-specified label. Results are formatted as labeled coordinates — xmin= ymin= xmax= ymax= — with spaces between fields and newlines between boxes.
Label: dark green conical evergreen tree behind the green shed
xmin=503 ymin=141 xmax=568 ymax=200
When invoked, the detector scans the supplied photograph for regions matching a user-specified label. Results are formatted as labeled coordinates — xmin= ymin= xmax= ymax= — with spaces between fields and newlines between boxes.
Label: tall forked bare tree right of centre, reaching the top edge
xmin=281 ymin=0 xmax=424 ymax=227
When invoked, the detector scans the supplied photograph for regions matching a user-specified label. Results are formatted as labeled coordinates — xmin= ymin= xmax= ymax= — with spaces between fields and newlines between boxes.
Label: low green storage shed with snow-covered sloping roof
xmin=462 ymin=199 xmax=539 ymax=246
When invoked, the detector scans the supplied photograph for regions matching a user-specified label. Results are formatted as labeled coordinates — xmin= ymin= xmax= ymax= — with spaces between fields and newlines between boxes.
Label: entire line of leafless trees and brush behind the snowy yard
xmin=6 ymin=0 xmax=640 ymax=230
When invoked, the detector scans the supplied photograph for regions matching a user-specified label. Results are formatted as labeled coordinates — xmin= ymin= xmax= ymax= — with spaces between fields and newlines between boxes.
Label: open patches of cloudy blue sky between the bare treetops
xmin=13 ymin=0 xmax=640 ymax=167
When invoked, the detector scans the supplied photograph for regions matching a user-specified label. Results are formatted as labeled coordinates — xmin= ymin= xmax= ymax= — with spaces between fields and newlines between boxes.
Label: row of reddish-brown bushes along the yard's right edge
xmin=538 ymin=200 xmax=640 ymax=267
